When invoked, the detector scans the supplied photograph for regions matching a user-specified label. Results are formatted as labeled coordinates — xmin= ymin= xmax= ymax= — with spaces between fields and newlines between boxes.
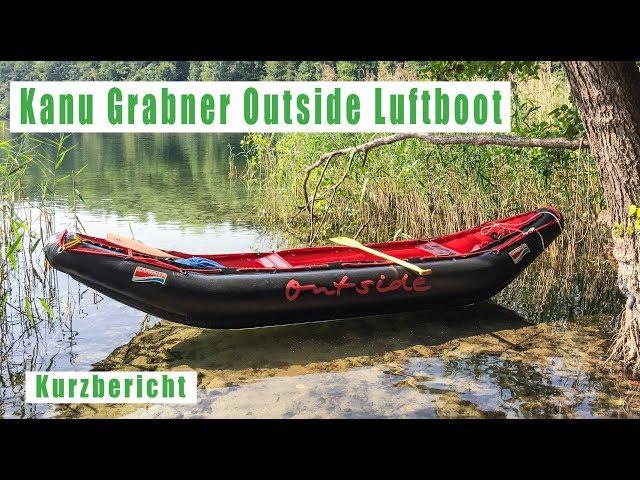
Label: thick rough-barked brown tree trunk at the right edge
xmin=563 ymin=62 xmax=640 ymax=374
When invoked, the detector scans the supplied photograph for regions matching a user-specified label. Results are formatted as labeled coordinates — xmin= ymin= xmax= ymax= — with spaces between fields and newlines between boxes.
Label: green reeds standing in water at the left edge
xmin=0 ymin=125 xmax=80 ymax=334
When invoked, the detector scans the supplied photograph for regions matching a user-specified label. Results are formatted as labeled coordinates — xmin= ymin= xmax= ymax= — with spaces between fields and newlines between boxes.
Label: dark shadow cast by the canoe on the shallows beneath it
xmin=96 ymin=302 xmax=529 ymax=371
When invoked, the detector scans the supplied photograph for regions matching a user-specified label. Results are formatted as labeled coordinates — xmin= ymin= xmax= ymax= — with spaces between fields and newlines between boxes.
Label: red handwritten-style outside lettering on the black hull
xmin=284 ymin=273 xmax=431 ymax=302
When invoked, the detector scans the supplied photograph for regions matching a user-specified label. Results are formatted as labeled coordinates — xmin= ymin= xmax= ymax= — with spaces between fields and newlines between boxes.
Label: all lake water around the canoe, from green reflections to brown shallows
xmin=0 ymin=134 xmax=640 ymax=418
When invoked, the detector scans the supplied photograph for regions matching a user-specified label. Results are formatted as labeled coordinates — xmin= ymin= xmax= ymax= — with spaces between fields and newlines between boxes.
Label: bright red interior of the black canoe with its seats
xmin=180 ymin=211 xmax=541 ymax=269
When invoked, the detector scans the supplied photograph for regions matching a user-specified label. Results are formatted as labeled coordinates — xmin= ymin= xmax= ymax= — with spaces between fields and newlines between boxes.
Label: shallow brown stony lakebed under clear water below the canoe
xmin=58 ymin=303 xmax=640 ymax=418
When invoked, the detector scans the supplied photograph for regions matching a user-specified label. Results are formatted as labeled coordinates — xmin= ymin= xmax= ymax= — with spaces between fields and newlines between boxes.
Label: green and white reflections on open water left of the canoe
xmin=0 ymin=134 xmax=282 ymax=417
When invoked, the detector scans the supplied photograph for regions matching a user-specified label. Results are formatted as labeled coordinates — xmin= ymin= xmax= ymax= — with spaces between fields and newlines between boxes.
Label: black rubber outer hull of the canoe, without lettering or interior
xmin=45 ymin=209 xmax=562 ymax=328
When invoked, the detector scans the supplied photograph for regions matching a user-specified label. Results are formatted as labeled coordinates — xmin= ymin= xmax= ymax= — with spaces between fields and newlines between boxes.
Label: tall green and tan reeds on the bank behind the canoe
xmin=242 ymin=134 xmax=608 ymax=249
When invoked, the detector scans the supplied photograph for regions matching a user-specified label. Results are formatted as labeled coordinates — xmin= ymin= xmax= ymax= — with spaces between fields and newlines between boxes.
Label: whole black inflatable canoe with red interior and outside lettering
xmin=45 ymin=207 xmax=563 ymax=328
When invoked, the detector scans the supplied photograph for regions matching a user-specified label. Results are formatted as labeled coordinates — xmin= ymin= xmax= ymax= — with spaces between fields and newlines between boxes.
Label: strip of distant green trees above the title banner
xmin=0 ymin=61 xmax=538 ymax=118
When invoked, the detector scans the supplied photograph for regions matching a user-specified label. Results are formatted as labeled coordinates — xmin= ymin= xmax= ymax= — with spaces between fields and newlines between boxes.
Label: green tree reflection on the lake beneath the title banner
xmin=25 ymin=133 xmax=253 ymax=227
